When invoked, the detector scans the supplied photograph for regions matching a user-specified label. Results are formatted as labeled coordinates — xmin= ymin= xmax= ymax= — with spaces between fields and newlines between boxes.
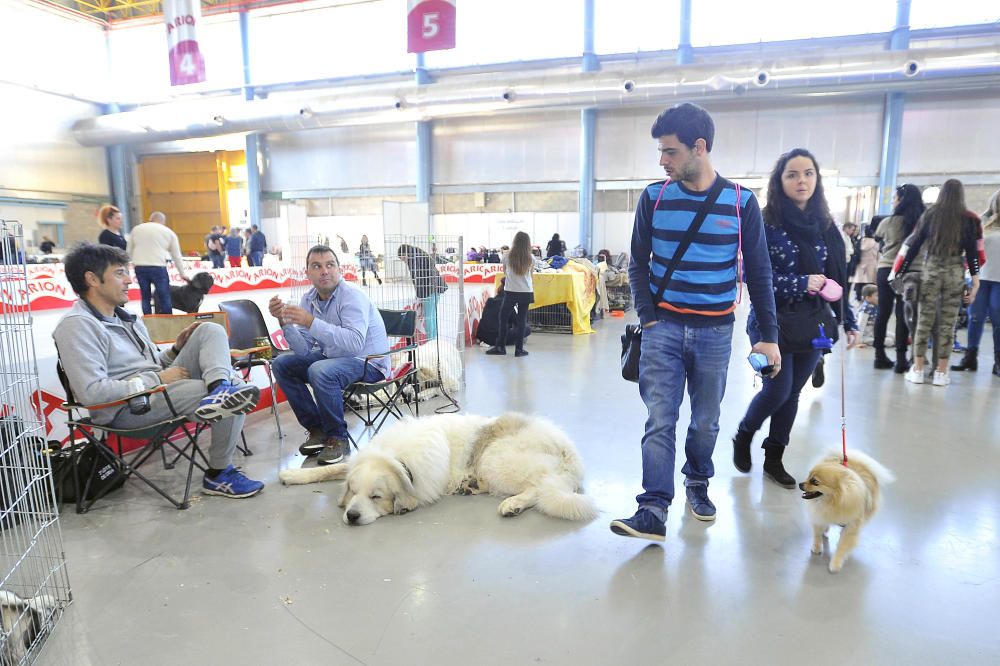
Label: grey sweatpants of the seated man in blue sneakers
xmin=111 ymin=322 xmax=244 ymax=469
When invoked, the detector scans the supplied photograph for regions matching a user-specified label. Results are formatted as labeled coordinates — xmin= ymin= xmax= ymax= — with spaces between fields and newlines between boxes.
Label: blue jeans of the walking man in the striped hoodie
xmin=636 ymin=320 xmax=733 ymax=519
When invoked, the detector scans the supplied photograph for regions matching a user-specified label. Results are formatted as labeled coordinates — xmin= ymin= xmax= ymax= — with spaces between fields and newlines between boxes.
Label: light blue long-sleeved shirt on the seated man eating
xmin=281 ymin=280 xmax=392 ymax=377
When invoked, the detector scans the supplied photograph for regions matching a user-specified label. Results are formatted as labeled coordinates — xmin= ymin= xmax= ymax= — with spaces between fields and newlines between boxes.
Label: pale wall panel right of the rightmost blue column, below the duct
xmin=899 ymin=94 xmax=1000 ymax=175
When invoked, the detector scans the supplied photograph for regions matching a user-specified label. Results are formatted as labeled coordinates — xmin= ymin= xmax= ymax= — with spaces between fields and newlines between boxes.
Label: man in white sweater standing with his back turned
xmin=128 ymin=211 xmax=188 ymax=314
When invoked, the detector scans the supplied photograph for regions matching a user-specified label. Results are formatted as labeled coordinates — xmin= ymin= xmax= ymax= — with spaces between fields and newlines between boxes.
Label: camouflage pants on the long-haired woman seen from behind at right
xmin=913 ymin=257 xmax=965 ymax=361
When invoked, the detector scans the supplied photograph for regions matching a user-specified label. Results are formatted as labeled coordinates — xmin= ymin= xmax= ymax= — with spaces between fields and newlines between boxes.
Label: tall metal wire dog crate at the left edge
xmin=0 ymin=221 xmax=72 ymax=666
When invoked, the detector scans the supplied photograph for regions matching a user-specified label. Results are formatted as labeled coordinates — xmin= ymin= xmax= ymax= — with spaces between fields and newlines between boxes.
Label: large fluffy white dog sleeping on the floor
xmin=279 ymin=413 xmax=597 ymax=525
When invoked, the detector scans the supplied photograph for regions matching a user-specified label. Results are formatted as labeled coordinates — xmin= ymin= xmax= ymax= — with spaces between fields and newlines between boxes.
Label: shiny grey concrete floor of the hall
xmin=40 ymin=308 xmax=1000 ymax=666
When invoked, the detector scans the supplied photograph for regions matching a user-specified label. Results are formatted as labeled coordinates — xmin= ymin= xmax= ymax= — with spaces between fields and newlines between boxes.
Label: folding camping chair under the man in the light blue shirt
xmin=344 ymin=309 xmax=420 ymax=440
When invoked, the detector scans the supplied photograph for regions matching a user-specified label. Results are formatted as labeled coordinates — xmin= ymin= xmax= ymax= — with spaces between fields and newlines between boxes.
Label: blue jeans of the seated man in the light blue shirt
xmin=271 ymin=352 xmax=383 ymax=439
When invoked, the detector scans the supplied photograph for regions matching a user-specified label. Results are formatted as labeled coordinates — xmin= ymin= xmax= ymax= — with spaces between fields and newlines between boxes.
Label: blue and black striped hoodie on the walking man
xmin=629 ymin=175 xmax=778 ymax=342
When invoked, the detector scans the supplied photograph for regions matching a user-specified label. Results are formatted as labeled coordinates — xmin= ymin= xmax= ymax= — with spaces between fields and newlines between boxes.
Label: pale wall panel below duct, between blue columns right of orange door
xmin=262 ymin=123 xmax=417 ymax=192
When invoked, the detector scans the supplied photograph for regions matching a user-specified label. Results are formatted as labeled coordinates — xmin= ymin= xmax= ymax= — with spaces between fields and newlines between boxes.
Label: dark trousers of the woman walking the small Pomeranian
xmin=740 ymin=350 xmax=820 ymax=446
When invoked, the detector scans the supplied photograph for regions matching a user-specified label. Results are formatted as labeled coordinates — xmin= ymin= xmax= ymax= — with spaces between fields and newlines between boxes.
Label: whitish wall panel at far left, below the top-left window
xmin=0 ymin=84 xmax=108 ymax=195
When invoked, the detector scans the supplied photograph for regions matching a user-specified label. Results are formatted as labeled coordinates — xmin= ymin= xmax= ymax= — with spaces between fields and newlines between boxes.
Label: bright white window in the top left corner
xmin=0 ymin=0 xmax=108 ymax=96
